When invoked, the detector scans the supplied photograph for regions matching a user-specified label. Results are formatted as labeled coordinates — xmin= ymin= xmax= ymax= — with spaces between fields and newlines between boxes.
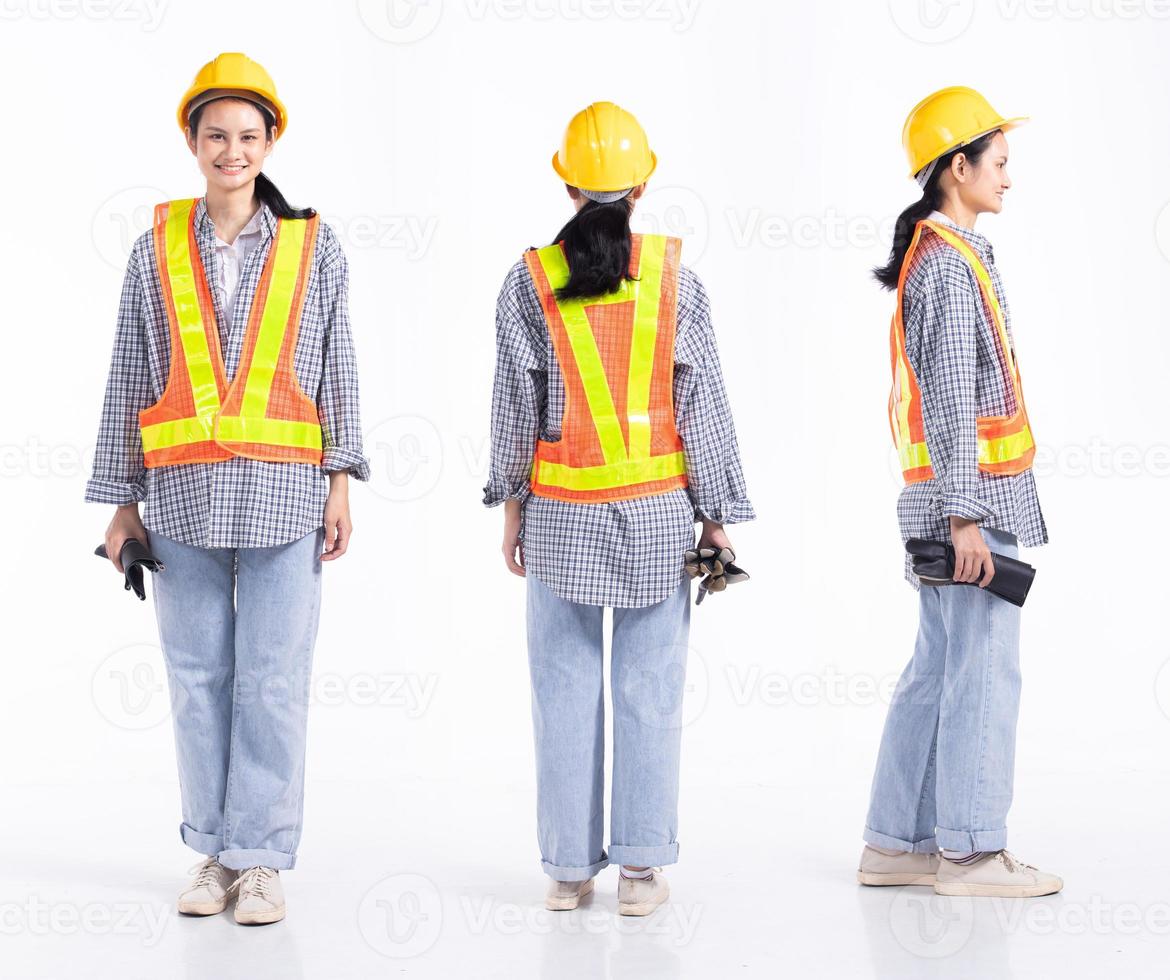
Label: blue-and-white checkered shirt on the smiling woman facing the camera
xmin=85 ymin=199 xmax=370 ymax=547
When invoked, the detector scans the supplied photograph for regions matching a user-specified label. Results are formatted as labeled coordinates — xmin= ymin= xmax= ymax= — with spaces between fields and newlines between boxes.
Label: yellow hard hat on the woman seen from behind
xmin=552 ymin=102 xmax=658 ymax=191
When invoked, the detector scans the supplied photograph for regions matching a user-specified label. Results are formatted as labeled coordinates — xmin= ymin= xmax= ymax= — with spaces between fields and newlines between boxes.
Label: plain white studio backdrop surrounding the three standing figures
xmin=0 ymin=0 xmax=1170 ymax=978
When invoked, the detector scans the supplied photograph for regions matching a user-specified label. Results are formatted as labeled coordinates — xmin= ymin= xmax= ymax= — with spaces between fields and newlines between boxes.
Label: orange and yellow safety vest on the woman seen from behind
xmin=524 ymin=234 xmax=687 ymax=503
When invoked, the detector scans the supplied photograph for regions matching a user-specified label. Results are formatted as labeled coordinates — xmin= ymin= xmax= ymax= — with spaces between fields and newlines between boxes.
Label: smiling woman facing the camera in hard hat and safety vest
xmin=85 ymin=53 xmax=370 ymax=923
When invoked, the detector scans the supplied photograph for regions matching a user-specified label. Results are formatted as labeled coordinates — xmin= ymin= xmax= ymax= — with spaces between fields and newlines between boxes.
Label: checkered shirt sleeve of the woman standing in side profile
xmin=908 ymin=248 xmax=993 ymax=520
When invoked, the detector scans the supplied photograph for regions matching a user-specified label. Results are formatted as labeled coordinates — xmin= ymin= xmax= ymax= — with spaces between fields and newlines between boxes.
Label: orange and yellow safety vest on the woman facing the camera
xmin=138 ymin=199 xmax=322 ymax=467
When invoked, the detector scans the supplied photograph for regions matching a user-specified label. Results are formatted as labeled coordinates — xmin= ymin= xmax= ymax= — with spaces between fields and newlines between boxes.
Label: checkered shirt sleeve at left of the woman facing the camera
xmin=85 ymin=240 xmax=156 ymax=506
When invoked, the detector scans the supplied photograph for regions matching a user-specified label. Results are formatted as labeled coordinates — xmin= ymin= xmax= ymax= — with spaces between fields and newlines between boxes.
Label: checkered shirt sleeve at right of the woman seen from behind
xmin=674 ymin=267 xmax=756 ymax=524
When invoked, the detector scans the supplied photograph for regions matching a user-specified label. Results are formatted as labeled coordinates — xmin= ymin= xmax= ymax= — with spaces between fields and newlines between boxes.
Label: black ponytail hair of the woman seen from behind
xmin=556 ymin=194 xmax=632 ymax=299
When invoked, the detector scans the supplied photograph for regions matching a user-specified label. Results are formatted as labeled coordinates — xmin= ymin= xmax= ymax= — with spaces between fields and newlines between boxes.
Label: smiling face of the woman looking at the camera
xmin=187 ymin=98 xmax=274 ymax=191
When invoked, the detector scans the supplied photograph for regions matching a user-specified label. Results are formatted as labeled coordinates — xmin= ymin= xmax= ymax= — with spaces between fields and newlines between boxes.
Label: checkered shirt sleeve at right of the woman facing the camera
xmin=317 ymin=223 xmax=370 ymax=481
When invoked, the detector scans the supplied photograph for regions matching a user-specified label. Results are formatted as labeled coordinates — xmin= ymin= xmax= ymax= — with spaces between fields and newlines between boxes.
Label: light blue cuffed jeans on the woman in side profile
xmin=863 ymin=529 xmax=1020 ymax=853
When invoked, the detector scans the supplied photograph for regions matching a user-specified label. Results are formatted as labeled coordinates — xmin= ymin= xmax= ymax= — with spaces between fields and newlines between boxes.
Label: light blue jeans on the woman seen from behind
xmin=525 ymin=572 xmax=690 ymax=882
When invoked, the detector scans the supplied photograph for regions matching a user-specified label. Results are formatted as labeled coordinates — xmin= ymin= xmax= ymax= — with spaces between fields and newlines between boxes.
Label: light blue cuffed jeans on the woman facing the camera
xmin=150 ymin=529 xmax=325 ymax=870
